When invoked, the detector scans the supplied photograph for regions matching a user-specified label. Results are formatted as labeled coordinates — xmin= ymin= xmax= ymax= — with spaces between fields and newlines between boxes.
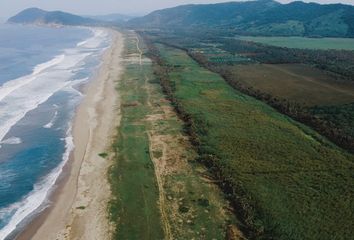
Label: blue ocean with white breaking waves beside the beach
xmin=0 ymin=24 xmax=110 ymax=240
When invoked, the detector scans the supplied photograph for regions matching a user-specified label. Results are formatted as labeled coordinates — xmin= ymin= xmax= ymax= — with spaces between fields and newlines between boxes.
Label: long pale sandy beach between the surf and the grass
xmin=18 ymin=30 xmax=123 ymax=240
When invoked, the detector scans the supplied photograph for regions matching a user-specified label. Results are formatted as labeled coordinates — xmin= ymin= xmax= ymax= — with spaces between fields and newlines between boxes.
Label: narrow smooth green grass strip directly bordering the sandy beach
xmin=109 ymin=33 xmax=164 ymax=239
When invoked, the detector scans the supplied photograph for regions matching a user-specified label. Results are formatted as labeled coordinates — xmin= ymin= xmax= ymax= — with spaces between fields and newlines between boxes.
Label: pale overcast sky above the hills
xmin=0 ymin=0 xmax=354 ymax=19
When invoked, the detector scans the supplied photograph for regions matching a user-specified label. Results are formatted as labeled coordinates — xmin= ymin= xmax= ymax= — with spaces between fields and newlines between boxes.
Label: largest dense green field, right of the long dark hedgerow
xmin=157 ymin=44 xmax=354 ymax=240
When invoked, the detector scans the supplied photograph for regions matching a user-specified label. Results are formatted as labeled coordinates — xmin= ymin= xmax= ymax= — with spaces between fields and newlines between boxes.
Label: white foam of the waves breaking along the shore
xmin=0 ymin=29 xmax=109 ymax=240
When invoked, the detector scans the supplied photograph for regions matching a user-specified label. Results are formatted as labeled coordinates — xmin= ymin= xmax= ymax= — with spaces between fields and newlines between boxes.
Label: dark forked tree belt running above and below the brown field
xmin=143 ymin=33 xmax=354 ymax=152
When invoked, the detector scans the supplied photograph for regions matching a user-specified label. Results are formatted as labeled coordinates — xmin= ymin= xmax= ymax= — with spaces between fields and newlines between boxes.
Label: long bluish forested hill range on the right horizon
xmin=128 ymin=0 xmax=354 ymax=37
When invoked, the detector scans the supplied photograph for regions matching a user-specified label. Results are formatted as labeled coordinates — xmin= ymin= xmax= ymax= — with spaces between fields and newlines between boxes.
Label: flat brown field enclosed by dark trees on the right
xmin=228 ymin=64 xmax=354 ymax=106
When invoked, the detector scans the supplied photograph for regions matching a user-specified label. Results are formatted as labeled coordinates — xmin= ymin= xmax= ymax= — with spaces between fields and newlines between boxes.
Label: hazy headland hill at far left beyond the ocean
xmin=7 ymin=8 xmax=101 ymax=25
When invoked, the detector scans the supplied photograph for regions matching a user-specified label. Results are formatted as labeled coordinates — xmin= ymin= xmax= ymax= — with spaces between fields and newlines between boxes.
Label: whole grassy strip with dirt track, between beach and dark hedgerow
xmin=109 ymin=32 xmax=243 ymax=240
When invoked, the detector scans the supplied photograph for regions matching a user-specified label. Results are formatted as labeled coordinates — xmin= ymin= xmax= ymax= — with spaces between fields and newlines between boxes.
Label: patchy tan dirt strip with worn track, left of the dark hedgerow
xmin=136 ymin=32 xmax=243 ymax=239
